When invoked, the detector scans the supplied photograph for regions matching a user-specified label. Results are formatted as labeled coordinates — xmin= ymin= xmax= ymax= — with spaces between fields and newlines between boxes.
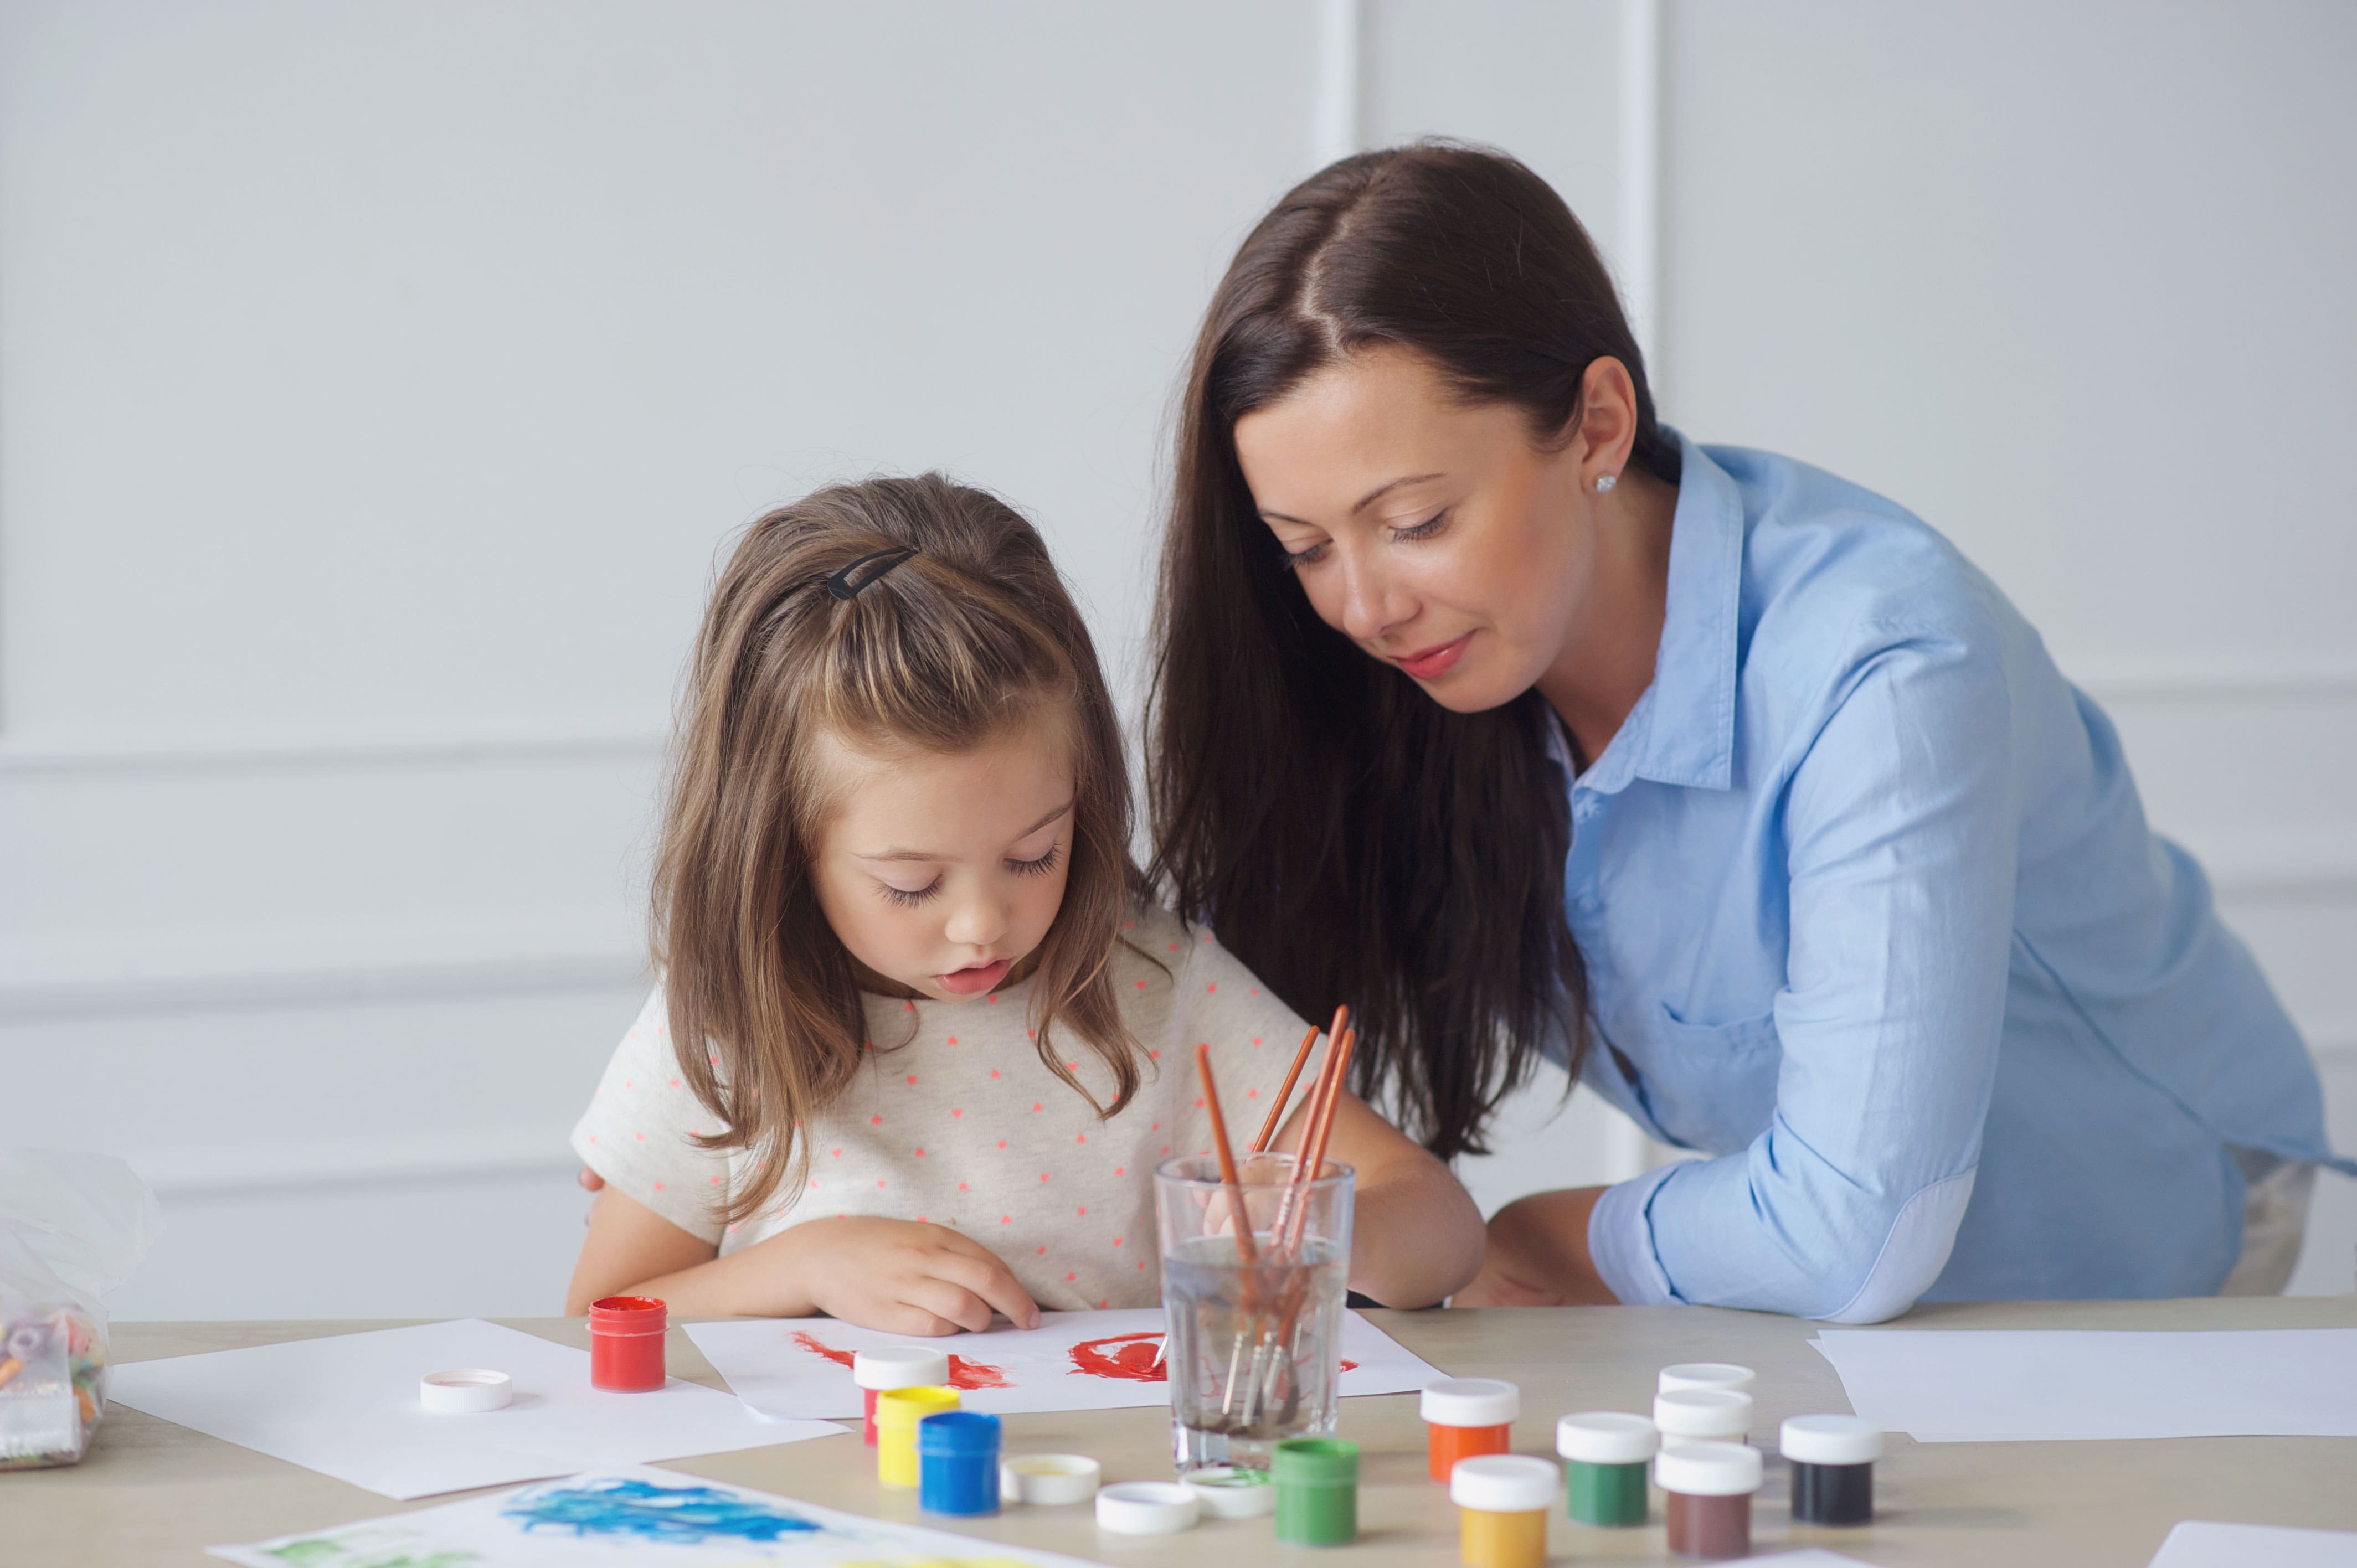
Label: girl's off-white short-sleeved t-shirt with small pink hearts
xmin=573 ymin=905 xmax=1325 ymax=1309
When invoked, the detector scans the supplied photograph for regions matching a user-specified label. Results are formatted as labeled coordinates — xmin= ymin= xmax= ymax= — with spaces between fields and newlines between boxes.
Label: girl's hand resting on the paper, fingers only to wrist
xmin=763 ymin=1216 xmax=1039 ymax=1334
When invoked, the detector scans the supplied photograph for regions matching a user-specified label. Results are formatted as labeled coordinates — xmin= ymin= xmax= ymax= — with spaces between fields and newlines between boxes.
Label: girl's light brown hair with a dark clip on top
xmin=653 ymin=474 xmax=1141 ymax=1221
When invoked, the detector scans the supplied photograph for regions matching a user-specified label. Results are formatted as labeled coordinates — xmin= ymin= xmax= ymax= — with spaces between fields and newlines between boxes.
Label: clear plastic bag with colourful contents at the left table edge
xmin=0 ymin=1148 xmax=163 ymax=1469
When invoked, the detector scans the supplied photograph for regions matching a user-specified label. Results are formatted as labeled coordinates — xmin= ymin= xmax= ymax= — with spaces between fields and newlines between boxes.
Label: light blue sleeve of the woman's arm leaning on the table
xmin=1586 ymin=622 xmax=2020 ymax=1323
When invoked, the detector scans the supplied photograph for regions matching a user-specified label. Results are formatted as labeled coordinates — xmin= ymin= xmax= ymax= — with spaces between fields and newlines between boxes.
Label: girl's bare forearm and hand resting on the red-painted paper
xmin=565 ymin=1186 xmax=1039 ymax=1334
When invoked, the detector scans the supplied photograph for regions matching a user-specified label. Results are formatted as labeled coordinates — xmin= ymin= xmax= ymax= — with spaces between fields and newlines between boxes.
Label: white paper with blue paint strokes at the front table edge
xmin=210 ymin=1467 xmax=1108 ymax=1568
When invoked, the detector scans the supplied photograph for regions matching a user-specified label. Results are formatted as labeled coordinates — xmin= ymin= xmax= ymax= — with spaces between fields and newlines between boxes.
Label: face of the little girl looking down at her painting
xmin=811 ymin=719 xmax=1072 ymax=1002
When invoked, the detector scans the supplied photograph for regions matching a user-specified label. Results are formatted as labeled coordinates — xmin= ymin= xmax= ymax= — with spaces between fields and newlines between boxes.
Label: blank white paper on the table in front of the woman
xmin=1815 ymin=1328 xmax=2357 ymax=1443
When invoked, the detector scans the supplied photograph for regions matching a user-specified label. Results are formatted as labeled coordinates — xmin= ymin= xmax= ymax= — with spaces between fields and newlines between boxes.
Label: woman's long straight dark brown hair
xmin=1148 ymin=142 xmax=1678 ymax=1158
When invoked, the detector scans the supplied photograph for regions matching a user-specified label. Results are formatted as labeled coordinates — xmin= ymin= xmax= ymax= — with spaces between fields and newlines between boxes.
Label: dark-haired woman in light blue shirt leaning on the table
xmin=1150 ymin=144 xmax=2348 ymax=1323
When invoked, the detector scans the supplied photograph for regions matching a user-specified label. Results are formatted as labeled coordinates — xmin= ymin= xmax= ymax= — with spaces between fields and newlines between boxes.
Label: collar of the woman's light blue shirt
xmin=1579 ymin=427 xmax=1744 ymax=795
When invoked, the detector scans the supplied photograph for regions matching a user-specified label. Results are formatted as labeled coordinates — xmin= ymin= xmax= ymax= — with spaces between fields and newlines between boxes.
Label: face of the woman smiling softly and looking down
xmin=1235 ymin=349 xmax=1596 ymax=712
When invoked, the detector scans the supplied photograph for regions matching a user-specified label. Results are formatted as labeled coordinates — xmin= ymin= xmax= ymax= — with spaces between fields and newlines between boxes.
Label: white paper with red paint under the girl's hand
xmin=688 ymin=1306 xmax=1440 ymax=1420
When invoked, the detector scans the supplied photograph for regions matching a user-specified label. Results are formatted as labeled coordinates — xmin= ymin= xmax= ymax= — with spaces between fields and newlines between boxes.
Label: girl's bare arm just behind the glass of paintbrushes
xmin=1275 ymin=1094 xmax=1483 ymax=1306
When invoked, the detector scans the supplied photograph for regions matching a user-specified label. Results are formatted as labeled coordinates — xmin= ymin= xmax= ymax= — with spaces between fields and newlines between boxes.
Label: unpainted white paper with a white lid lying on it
xmin=106 ymin=1318 xmax=844 ymax=1497
